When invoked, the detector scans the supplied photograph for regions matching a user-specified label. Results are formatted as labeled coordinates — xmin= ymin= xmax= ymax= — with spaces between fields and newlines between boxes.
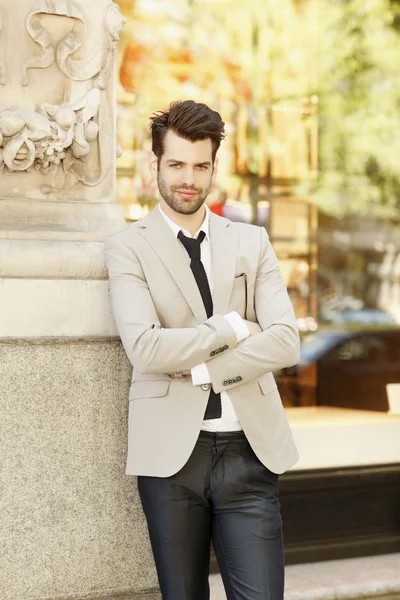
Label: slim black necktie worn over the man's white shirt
xmin=178 ymin=231 xmax=222 ymax=419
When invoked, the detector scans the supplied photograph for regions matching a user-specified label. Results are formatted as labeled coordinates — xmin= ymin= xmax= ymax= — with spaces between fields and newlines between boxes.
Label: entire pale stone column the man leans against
xmin=0 ymin=0 xmax=157 ymax=600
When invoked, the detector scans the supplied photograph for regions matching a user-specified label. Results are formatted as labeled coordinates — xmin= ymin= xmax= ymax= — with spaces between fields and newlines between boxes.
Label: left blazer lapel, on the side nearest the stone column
xmin=140 ymin=208 xmax=207 ymax=323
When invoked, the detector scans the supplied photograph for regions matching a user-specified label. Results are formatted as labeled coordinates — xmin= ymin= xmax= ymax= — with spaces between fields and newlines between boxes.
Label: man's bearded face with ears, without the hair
xmin=150 ymin=131 xmax=216 ymax=215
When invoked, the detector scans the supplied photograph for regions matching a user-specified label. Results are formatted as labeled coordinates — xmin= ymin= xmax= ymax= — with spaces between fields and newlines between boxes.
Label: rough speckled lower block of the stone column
xmin=0 ymin=338 xmax=157 ymax=600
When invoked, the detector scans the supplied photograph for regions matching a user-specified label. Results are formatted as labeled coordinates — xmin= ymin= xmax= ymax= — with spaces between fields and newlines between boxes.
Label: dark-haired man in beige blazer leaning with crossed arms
xmin=106 ymin=101 xmax=299 ymax=600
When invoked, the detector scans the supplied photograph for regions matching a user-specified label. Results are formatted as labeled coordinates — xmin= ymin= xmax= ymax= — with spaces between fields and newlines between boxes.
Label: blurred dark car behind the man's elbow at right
xmin=275 ymin=327 xmax=400 ymax=411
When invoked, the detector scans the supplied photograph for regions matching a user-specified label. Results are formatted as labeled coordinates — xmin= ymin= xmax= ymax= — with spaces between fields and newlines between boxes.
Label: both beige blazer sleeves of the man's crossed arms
xmin=106 ymin=228 xmax=299 ymax=392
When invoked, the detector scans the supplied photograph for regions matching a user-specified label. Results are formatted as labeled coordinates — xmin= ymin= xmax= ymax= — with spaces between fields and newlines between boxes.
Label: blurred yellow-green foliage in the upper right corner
xmin=314 ymin=0 xmax=400 ymax=218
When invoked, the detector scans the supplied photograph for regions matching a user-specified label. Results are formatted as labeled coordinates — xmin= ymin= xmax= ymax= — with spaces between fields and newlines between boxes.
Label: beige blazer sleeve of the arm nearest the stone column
xmin=105 ymin=238 xmax=237 ymax=373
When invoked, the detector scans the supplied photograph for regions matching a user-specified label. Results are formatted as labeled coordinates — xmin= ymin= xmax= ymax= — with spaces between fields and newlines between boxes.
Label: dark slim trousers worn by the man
xmin=138 ymin=432 xmax=284 ymax=600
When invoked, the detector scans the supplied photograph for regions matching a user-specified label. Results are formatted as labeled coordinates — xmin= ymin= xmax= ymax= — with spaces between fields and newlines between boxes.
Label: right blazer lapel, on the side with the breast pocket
xmin=210 ymin=213 xmax=238 ymax=315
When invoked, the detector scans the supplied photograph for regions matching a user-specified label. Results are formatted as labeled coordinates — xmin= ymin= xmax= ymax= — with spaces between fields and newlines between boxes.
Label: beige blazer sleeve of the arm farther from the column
xmin=207 ymin=228 xmax=300 ymax=393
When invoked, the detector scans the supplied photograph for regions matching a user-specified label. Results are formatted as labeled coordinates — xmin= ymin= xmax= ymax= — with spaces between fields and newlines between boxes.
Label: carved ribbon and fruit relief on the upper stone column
xmin=0 ymin=0 xmax=126 ymax=194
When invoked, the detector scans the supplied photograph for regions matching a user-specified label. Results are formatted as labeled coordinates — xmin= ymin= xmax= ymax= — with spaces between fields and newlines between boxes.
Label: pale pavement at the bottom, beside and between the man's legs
xmin=210 ymin=553 xmax=400 ymax=600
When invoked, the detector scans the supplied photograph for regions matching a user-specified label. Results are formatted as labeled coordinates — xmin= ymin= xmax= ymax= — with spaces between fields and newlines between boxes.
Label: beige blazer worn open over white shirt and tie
xmin=105 ymin=209 xmax=299 ymax=477
